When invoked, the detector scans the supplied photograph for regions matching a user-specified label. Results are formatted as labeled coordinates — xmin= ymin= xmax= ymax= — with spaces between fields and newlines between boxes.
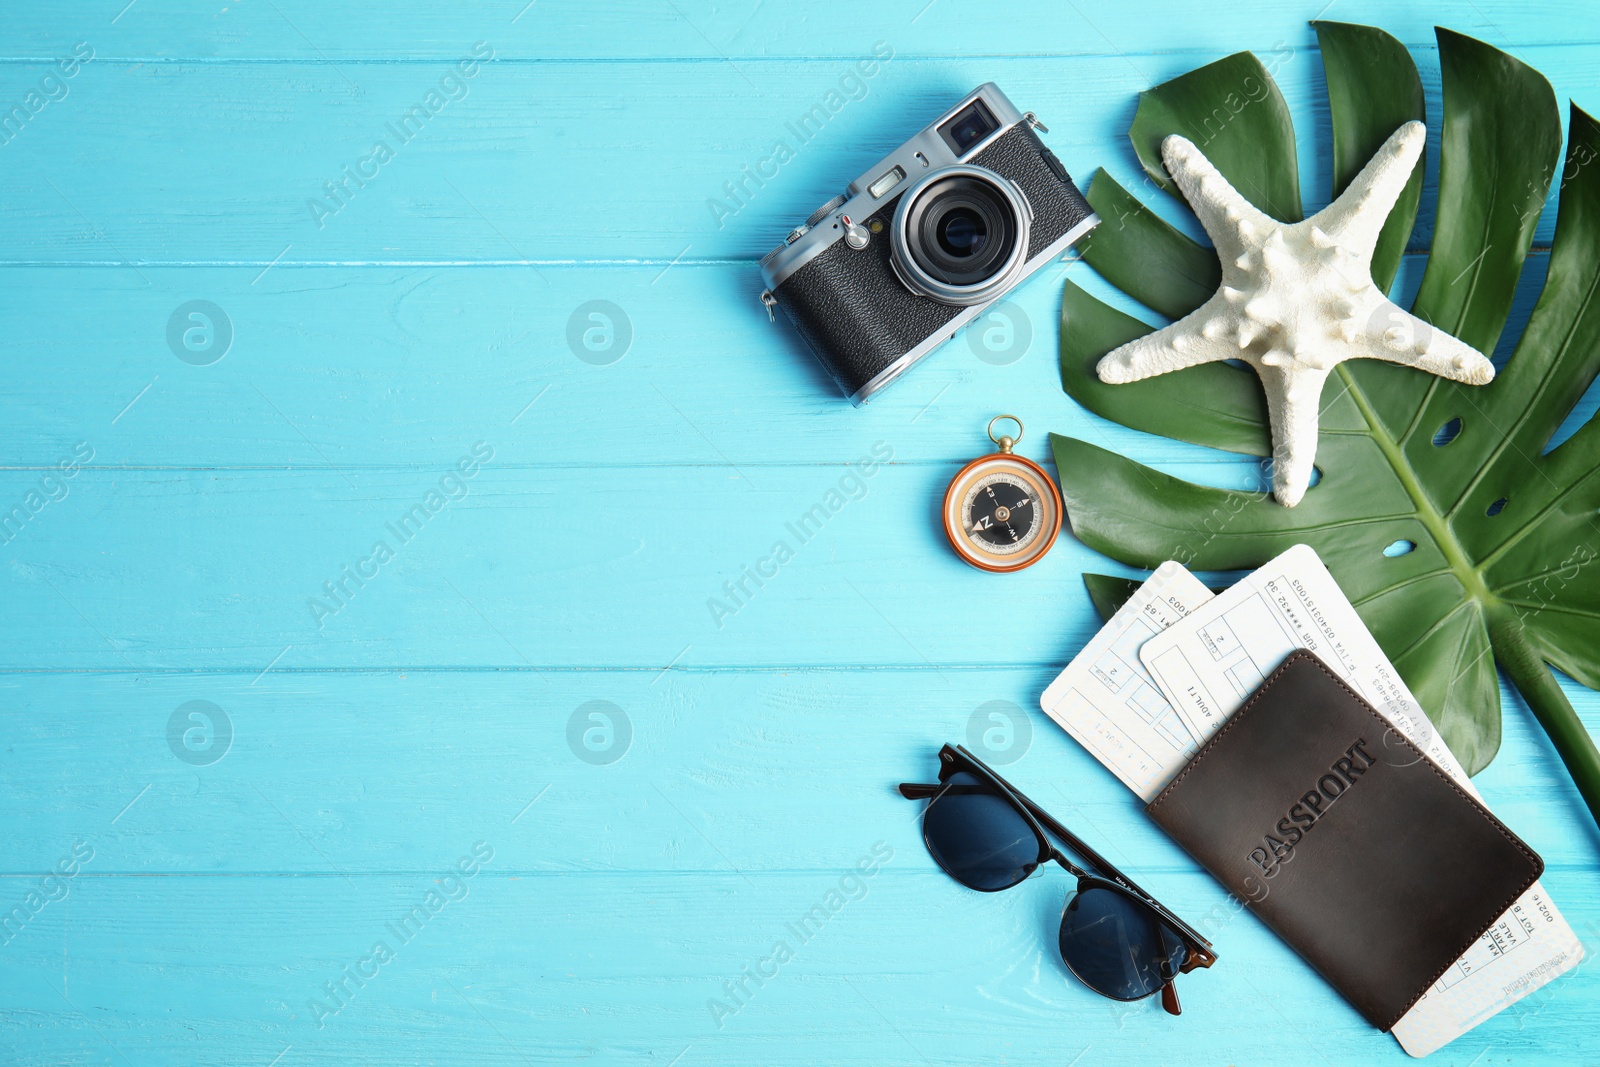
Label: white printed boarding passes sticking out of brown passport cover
xmin=1040 ymin=545 xmax=1582 ymax=1056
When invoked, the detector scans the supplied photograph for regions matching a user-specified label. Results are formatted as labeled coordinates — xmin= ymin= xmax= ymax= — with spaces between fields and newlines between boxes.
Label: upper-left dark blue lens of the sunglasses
xmin=922 ymin=771 xmax=1038 ymax=891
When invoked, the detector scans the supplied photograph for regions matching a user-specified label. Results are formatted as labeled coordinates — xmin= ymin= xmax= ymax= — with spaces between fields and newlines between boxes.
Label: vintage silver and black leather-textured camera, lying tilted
xmin=762 ymin=82 xmax=1099 ymax=405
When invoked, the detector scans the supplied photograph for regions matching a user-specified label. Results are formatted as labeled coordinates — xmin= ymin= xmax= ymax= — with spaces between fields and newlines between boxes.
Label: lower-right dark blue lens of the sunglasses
xmin=1061 ymin=886 xmax=1187 ymax=1000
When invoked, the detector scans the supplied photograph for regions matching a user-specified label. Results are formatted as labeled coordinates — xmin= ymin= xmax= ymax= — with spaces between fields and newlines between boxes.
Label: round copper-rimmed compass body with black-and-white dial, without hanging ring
xmin=944 ymin=453 xmax=1062 ymax=571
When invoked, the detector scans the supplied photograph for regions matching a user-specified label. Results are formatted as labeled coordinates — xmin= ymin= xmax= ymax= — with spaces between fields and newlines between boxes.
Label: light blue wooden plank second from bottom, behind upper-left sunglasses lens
xmin=0 ymin=668 xmax=1600 ymax=876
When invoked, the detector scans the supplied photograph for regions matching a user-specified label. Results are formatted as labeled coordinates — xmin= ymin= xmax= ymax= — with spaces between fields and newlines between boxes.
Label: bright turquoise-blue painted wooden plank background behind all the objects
xmin=0 ymin=0 xmax=1600 ymax=1067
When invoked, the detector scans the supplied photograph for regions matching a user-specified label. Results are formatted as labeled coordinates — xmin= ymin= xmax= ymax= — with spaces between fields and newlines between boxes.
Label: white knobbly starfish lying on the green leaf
xmin=1098 ymin=122 xmax=1494 ymax=507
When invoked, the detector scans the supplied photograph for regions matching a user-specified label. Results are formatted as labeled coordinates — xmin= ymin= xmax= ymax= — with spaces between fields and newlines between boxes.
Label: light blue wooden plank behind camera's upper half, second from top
xmin=0 ymin=46 xmax=1600 ymax=262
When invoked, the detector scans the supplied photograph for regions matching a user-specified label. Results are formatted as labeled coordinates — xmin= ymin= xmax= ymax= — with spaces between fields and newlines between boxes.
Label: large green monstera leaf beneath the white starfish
xmin=1053 ymin=22 xmax=1600 ymax=811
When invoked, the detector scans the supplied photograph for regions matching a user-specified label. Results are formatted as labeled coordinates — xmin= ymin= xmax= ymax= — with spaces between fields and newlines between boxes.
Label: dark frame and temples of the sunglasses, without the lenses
xmin=899 ymin=744 xmax=1216 ymax=1014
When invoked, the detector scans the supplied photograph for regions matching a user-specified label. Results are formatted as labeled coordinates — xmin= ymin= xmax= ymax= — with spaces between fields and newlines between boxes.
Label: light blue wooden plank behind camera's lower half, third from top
xmin=0 ymin=253 xmax=1574 ymax=470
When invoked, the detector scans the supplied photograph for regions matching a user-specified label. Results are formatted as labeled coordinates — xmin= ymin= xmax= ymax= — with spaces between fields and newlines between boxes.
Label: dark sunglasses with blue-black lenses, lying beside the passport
xmin=899 ymin=745 xmax=1216 ymax=1016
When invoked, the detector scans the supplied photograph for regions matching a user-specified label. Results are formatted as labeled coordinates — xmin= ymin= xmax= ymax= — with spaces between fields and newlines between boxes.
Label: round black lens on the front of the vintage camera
xmin=906 ymin=174 xmax=1021 ymax=288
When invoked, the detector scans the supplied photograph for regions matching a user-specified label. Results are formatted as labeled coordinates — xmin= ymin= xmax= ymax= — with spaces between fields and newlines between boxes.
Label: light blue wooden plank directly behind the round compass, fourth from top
xmin=0 ymin=457 xmax=1194 ymax=670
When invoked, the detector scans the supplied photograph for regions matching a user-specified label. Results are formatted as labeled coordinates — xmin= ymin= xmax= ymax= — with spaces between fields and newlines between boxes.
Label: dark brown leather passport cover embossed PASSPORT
xmin=1146 ymin=651 xmax=1544 ymax=1030
